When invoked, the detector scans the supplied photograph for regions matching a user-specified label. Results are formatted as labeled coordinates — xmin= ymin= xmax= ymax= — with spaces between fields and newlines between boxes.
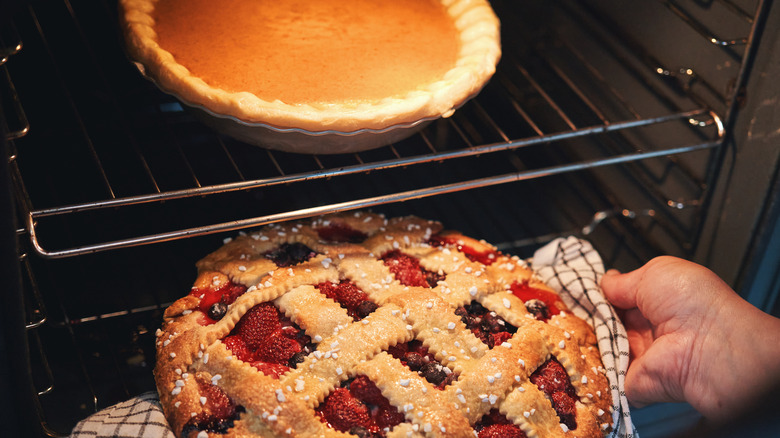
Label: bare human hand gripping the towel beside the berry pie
xmin=601 ymin=257 xmax=780 ymax=420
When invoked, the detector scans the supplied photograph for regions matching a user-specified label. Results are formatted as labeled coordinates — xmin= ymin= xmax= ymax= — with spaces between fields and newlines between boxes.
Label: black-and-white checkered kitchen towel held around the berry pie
xmin=71 ymin=237 xmax=638 ymax=438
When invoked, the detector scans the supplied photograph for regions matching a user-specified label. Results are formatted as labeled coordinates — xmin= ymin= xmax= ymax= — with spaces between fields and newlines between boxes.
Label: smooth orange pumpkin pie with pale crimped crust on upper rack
xmin=119 ymin=0 xmax=501 ymax=132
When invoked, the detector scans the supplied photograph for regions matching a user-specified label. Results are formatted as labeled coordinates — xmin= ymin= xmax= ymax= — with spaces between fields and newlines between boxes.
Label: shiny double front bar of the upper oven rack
xmin=18 ymin=111 xmax=722 ymax=258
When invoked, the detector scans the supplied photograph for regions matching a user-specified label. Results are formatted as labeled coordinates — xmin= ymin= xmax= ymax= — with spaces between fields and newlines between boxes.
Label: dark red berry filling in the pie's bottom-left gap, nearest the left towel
xmin=181 ymin=378 xmax=244 ymax=436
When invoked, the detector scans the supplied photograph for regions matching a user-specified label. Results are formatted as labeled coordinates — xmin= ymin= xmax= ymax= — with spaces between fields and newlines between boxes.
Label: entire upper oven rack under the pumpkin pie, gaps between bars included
xmin=4 ymin=0 xmax=765 ymax=258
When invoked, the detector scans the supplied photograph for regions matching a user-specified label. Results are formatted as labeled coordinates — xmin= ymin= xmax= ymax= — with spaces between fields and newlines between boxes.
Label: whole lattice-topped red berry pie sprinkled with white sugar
xmin=155 ymin=212 xmax=612 ymax=438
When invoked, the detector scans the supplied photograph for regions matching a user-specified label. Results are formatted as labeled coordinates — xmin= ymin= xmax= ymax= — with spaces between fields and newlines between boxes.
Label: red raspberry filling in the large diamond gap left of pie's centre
xmin=222 ymin=303 xmax=314 ymax=378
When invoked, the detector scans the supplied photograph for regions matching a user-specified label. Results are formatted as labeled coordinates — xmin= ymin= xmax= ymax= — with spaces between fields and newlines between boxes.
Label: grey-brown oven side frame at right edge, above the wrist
xmin=694 ymin=0 xmax=780 ymax=302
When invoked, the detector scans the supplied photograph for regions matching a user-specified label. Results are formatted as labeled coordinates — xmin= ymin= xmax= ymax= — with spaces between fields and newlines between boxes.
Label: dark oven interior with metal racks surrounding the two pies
xmin=0 ymin=0 xmax=780 ymax=437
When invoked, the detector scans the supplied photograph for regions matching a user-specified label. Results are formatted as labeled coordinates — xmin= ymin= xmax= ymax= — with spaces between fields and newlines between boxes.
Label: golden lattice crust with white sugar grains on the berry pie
xmin=155 ymin=212 xmax=612 ymax=438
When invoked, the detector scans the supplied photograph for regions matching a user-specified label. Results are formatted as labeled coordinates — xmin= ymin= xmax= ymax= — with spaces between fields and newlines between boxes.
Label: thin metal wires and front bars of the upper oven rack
xmin=3 ymin=0 xmax=760 ymax=258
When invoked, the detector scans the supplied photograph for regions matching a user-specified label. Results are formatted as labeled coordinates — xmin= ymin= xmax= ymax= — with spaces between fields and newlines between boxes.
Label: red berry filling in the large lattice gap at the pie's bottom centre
xmin=316 ymin=376 xmax=404 ymax=437
